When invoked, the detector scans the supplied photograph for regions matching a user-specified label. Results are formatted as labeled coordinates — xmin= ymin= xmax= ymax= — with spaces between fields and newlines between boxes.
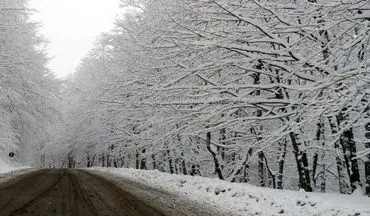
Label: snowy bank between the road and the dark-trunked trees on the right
xmin=92 ymin=168 xmax=370 ymax=216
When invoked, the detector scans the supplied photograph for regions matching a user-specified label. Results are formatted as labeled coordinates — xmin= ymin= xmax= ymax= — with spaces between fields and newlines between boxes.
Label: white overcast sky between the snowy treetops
xmin=30 ymin=0 xmax=122 ymax=78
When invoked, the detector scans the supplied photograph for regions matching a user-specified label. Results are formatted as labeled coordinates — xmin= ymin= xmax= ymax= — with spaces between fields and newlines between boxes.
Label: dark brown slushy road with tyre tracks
xmin=0 ymin=169 xmax=220 ymax=216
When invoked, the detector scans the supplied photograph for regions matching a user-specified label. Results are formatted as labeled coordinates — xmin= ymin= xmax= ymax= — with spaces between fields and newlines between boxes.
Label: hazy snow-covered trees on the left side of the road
xmin=0 ymin=0 xmax=59 ymax=163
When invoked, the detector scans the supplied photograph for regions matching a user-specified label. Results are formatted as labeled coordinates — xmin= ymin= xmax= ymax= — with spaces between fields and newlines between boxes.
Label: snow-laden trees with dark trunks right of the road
xmin=46 ymin=0 xmax=370 ymax=193
